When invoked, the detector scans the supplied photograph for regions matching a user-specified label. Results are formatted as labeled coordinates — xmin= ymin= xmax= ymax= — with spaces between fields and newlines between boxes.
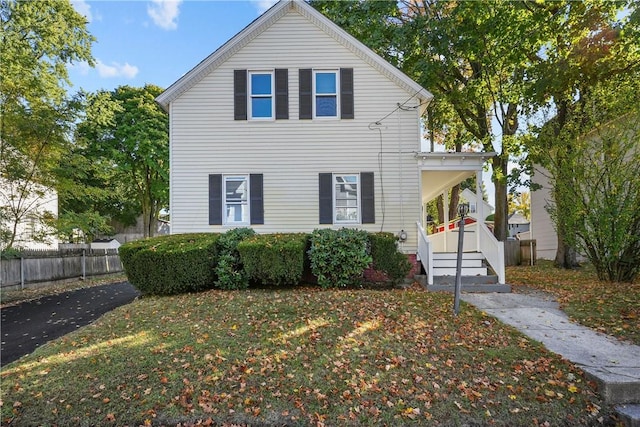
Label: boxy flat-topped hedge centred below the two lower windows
xmin=238 ymin=233 xmax=308 ymax=285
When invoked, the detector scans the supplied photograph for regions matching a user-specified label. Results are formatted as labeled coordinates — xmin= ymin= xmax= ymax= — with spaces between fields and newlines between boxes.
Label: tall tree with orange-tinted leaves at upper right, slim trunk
xmin=526 ymin=0 xmax=640 ymax=268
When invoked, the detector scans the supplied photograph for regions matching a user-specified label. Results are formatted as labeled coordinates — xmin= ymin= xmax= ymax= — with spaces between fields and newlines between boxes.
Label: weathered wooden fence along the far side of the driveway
xmin=0 ymin=249 xmax=122 ymax=289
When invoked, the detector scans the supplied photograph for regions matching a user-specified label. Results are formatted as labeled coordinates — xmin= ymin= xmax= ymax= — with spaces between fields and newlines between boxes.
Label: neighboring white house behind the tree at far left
xmin=0 ymin=179 xmax=58 ymax=250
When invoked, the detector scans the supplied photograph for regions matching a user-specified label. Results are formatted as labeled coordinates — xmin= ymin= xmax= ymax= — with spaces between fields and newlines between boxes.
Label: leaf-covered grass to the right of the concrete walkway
xmin=507 ymin=261 xmax=640 ymax=345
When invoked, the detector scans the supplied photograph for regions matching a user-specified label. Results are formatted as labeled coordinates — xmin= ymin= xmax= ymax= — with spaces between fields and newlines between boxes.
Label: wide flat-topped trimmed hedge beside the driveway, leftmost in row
xmin=119 ymin=233 xmax=220 ymax=295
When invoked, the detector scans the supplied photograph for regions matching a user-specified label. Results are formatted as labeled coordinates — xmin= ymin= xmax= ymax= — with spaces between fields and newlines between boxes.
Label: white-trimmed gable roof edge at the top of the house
xmin=156 ymin=0 xmax=433 ymax=114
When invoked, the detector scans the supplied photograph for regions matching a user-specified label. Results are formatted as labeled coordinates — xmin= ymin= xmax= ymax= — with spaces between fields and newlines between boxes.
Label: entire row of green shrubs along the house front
xmin=120 ymin=228 xmax=411 ymax=295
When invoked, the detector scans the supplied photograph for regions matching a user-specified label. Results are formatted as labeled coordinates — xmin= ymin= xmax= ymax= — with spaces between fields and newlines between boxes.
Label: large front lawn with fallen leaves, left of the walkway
xmin=1 ymin=287 xmax=613 ymax=426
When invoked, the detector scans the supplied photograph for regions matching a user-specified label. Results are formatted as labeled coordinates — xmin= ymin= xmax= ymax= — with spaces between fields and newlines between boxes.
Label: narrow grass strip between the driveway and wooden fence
xmin=0 ymin=273 xmax=127 ymax=307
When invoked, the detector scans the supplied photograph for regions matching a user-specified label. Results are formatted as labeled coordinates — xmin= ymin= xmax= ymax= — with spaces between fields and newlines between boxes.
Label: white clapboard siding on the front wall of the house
xmin=170 ymin=10 xmax=420 ymax=252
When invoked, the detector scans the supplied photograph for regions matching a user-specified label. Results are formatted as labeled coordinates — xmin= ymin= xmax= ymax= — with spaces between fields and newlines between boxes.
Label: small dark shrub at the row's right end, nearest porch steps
xmin=369 ymin=232 xmax=411 ymax=283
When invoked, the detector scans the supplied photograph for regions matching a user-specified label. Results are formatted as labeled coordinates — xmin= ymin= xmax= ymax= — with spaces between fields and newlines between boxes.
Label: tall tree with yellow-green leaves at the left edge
xmin=0 ymin=0 xmax=94 ymax=247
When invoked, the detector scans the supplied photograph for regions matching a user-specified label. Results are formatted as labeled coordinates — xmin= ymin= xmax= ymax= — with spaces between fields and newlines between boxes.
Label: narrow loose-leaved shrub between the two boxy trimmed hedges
xmin=215 ymin=227 xmax=256 ymax=290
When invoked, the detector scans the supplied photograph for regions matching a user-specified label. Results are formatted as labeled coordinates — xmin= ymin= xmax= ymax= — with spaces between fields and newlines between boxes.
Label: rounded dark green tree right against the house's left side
xmin=76 ymin=85 xmax=169 ymax=237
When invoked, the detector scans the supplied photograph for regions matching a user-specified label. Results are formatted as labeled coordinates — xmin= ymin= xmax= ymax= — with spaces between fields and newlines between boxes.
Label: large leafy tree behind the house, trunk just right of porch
xmin=312 ymin=0 xmax=543 ymax=240
